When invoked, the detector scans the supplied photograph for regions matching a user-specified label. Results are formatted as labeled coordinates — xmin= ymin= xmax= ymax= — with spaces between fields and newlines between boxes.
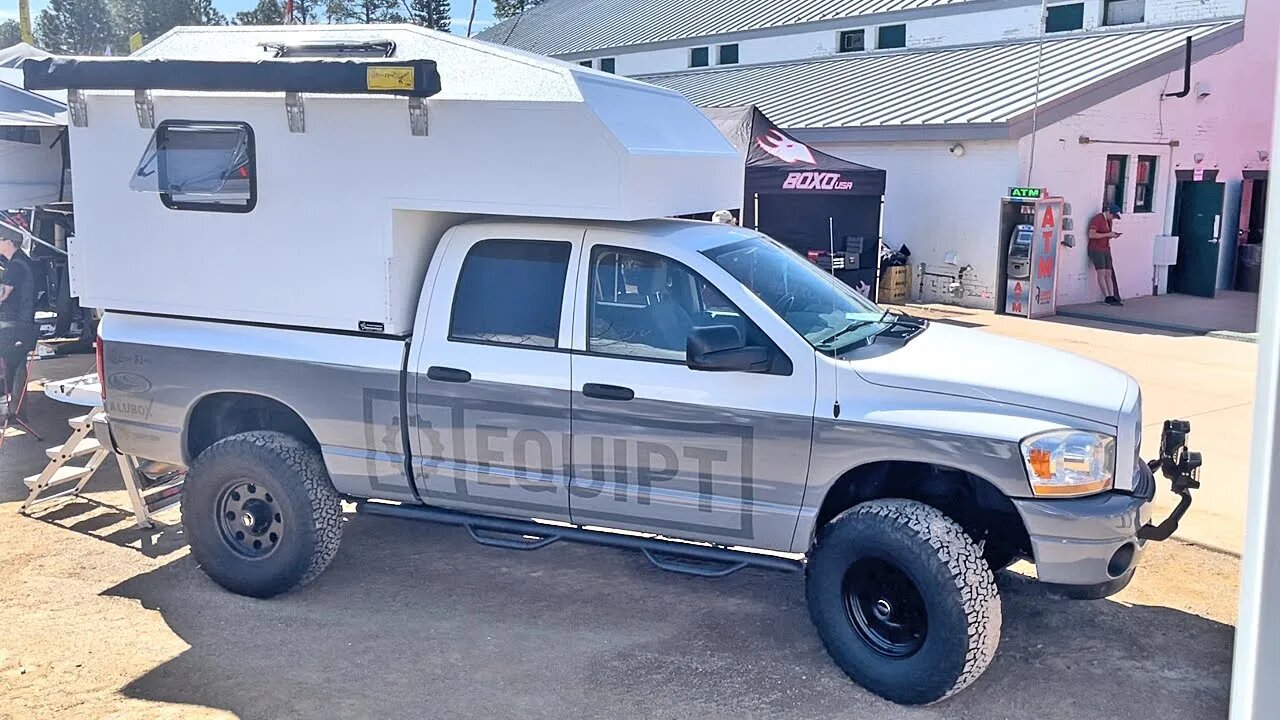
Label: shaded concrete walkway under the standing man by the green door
xmin=1057 ymin=290 xmax=1258 ymax=342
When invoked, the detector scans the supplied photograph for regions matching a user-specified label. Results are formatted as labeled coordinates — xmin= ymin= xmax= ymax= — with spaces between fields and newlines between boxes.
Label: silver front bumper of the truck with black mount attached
xmin=1014 ymin=420 xmax=1201 ymax=597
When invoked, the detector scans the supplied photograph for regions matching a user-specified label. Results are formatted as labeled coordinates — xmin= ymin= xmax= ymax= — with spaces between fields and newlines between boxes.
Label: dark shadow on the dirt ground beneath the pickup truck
xmin=108 ymin=516 xmax=1233 ymax=720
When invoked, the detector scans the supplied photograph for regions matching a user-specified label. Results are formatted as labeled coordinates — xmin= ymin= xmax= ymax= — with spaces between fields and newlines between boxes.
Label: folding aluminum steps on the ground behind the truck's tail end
xmin=19 ymin=407 xmax=184 ymax=528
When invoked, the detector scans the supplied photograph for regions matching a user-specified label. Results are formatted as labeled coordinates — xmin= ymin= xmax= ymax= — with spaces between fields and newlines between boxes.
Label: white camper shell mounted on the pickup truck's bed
xmin=42 ymin=26 xmax=742 ymax=334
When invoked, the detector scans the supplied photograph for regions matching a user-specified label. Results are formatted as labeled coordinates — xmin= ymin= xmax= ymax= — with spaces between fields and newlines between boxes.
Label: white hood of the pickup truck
xmin=850 ymin=323 xmax=1137 ymax=427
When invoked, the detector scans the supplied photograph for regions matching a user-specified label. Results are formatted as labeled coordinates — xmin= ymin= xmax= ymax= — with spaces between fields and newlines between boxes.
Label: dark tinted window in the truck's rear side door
xmin=449 ymin=240 xmax=570 ymax=347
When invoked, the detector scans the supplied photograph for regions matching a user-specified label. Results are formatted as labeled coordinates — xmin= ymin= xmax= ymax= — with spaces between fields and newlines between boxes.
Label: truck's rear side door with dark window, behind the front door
xmin=407 ymin=223 xmax=582 ymax=521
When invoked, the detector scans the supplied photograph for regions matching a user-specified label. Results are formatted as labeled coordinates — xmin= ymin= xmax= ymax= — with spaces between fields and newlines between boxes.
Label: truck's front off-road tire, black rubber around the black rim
xmin=805 ymin=500 xmax=1001 ymax=705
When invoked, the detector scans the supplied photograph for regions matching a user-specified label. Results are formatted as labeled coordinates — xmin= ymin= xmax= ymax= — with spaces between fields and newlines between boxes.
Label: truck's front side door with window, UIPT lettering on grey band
xmin=570 ymin=228 xmax=815 ymax=550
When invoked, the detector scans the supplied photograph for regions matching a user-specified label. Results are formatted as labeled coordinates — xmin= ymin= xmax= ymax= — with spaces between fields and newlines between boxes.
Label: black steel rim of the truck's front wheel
xmin=844 ymin=557 xmax=929 ymax=657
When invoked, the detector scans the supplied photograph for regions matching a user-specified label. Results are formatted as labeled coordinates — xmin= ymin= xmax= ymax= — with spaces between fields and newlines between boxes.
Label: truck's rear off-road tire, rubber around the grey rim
xmin=182 ymin=430 xmax=342 ymax=597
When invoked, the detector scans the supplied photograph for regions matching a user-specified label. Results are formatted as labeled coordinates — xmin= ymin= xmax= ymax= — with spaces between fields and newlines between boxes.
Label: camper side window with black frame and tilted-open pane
xmin=129 ymin=120 xmax=257 ymax=213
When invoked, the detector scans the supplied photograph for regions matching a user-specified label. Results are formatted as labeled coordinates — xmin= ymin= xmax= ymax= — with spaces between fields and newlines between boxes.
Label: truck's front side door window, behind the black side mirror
xmin=586 ymin=247 xmax=772 ymax=363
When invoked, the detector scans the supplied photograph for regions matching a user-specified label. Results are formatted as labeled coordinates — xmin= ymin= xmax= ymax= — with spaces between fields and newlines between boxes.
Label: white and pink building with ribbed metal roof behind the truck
xmin=483 ymin=0 xmax=1280 ymax=307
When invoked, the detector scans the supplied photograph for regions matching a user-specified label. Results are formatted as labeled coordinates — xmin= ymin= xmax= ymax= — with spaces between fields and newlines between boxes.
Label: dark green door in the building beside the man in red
xmin=1169 ymin=181 xmax=1225 ymax=297
